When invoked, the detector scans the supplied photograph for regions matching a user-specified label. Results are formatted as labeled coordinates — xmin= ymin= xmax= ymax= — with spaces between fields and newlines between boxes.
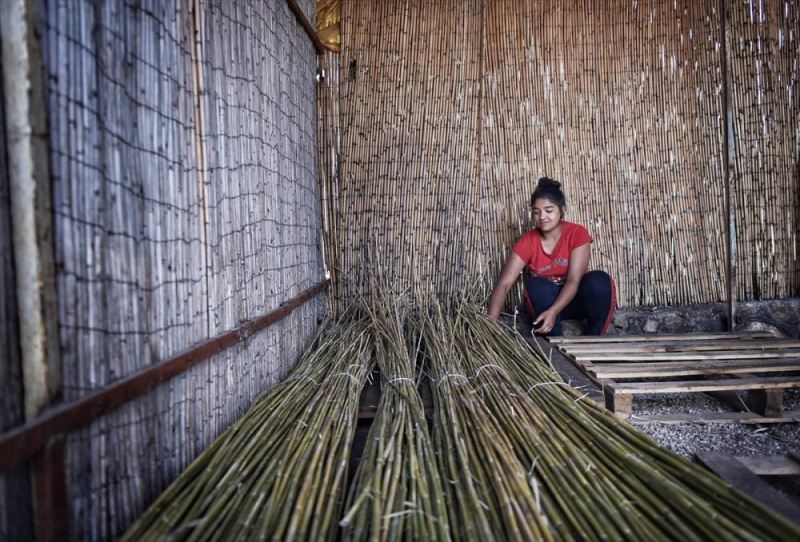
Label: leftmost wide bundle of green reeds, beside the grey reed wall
xmin=123 ymin=321 xmax=372 ymax=541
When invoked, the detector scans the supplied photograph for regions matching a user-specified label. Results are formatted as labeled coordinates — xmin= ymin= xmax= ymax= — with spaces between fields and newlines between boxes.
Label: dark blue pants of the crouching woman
xmin=525 ymin=271 xmax=617 ymax=335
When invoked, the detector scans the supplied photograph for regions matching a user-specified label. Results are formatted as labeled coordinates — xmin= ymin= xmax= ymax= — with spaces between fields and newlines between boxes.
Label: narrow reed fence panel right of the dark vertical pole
xmin=728 ymin=0 xmax=800 ymax=299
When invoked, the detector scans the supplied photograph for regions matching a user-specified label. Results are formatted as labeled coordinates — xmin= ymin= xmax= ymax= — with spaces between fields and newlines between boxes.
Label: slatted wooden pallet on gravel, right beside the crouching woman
xmin=550 ymin=332 xmax=800 ymax=423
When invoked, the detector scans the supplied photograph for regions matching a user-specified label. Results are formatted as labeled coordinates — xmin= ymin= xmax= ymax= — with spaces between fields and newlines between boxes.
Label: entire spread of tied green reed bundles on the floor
xmin=126 ymin=294 xmax=800 ymax=541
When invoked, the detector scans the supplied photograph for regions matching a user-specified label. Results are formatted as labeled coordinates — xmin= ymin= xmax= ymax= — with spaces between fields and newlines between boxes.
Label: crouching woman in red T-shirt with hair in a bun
xmin=489 ymin=177 xmax=616 ymax=335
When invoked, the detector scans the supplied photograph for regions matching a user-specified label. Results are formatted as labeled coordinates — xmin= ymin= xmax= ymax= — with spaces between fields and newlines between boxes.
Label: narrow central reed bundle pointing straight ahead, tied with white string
xmin=340 ymin=296 xmax=450 ymax=540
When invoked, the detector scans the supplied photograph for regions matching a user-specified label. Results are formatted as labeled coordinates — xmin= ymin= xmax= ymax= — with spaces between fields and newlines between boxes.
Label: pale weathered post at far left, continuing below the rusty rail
xmin=0 ymin=0 xmax=69 ymax=541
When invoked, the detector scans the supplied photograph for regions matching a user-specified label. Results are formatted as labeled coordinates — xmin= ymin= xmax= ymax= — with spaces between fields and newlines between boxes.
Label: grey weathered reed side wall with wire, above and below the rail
xmin=37 ymin=0 xmax=324 ymax=540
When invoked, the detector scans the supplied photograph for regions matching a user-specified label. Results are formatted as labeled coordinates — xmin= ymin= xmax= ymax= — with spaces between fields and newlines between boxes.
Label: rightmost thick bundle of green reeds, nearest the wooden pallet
xmin=456 ymin=307 xmax=800 ymax=540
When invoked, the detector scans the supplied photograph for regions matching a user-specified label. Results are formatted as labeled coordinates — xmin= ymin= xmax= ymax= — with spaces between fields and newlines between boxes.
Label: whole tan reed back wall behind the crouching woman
xmin=319 ymin=0 xmax=800 ymax=307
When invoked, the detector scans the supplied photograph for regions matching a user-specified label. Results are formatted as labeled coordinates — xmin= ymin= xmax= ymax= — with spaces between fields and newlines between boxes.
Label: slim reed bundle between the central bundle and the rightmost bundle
xmin=416 ymin=303 xmax=552 ymax=540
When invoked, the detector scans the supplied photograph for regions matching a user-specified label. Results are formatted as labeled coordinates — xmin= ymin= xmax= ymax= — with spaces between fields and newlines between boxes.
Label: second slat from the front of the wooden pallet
xmin=587 ymin=360 xmax=800 ymax=378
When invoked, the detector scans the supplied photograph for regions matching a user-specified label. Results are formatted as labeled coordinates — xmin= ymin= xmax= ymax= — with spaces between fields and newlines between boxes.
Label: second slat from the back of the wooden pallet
xmin=560 ymin=339 xmax=800 ymax=354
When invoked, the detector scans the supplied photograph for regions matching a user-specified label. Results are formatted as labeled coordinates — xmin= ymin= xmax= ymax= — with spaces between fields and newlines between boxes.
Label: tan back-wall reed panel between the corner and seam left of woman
xmin=327 ymin=1 xmax=480 ymax=308
